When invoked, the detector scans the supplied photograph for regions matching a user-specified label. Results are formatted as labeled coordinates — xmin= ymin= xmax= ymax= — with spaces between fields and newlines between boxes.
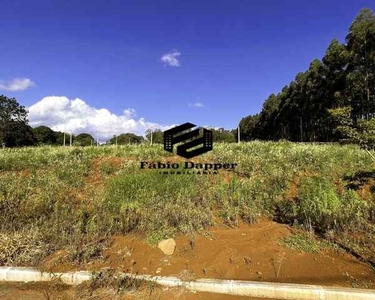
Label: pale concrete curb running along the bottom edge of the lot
xmin=0 ymin=267 xmax=375 ymax=300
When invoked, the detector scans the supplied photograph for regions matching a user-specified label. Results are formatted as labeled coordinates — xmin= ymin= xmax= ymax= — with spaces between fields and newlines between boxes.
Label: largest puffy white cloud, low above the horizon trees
xmin=28 ymin=96 xmax=170 ymax=140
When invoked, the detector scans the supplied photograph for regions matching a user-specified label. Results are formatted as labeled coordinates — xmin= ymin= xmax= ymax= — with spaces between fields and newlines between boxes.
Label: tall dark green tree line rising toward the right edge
xmin=239 ymin=8 xmax=375 ymax=146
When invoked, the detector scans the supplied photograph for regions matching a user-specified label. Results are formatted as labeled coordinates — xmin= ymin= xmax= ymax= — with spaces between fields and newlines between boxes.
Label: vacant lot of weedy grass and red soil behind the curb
xmin=0 ymin=142 xmax=375 ymax=287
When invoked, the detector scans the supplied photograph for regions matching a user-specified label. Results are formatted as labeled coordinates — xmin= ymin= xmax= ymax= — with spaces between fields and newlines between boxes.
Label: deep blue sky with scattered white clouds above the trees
xmin=0 ymin=0 xmax=375 ymax=137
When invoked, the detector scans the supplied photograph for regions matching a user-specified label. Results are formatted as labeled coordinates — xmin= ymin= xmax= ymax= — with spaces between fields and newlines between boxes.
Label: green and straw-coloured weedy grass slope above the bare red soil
xmin=0 ymin=142 xmax=375 ymax=265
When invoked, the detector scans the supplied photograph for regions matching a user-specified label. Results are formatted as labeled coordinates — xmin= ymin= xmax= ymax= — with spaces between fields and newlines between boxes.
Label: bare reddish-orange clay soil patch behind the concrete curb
xmin=41 ymin=220 xmax=375 ymax=288
